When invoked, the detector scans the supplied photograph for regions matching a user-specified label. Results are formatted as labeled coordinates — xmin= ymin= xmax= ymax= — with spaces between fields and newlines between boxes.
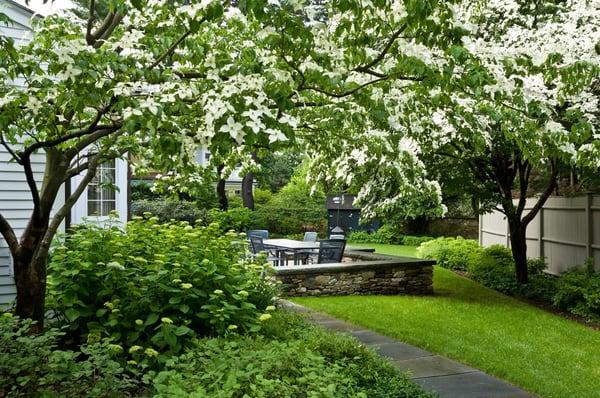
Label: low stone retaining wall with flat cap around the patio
xmin=275 ymin=252 xmax=435 ymax=296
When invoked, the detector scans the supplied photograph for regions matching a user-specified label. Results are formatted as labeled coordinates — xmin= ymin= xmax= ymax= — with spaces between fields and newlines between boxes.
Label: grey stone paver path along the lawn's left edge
xmin=281 ymin=300 xmax=535 ymax=398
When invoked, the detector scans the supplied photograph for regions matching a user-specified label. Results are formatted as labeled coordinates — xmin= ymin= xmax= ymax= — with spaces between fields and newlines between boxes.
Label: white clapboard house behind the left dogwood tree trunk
xmin=0 ymin=0 xmax=128 ymax=305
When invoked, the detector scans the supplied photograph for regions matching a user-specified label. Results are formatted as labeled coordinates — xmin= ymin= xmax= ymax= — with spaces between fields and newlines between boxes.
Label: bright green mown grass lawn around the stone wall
xmin=294 ymin=245 xmax=600 ymax=398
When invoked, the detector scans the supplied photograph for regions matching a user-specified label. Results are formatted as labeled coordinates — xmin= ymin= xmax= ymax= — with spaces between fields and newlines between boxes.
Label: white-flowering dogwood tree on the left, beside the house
xmin=0 ymin=0 xmax=461 ymax=325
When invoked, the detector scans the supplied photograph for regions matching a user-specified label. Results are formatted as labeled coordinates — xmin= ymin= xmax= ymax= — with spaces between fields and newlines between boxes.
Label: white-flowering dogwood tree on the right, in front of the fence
xmin=316 ymin=0 xmax=600 ymax=283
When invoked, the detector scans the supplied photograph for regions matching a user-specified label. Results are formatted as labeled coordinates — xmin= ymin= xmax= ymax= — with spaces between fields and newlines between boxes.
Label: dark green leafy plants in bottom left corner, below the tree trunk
xmin=0 ymin=313 xmax=136 ymax=397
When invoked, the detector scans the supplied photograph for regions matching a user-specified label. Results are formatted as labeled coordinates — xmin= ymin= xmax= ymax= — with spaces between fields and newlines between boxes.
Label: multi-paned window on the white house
xmin=88 ymin=159 xmax=117 ymax=216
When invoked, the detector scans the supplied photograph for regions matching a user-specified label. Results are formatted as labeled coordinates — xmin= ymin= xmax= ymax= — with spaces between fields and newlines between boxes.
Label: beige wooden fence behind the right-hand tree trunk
xmin=479 ymin=195 xmax=600 ymax=274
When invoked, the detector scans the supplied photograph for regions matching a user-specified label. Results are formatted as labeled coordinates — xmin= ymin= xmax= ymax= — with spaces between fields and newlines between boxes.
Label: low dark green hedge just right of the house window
xmin=131 ymin=199 xmax=207 ymax=225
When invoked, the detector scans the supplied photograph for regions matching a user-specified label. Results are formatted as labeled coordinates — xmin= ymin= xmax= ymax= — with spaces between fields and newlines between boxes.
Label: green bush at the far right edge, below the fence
xmin=553 ymin=262 xmax=600 ymax=319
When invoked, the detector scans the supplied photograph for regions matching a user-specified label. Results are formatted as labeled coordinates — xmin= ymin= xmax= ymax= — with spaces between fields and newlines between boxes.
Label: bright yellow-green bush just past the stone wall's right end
xmin=417 ymin=236 xmax=482 ymax=270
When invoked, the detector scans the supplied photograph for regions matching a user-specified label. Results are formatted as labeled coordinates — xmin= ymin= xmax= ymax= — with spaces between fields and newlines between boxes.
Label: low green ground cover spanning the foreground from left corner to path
xmin=0 ymin=311 xmax=435 ymax=398
